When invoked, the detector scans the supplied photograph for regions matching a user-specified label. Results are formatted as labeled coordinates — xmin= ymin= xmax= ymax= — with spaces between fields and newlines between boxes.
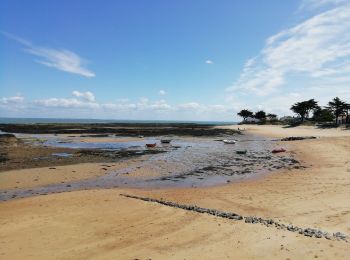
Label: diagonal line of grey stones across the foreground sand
xmin=120 ymin=194 xmax=348 ymax=242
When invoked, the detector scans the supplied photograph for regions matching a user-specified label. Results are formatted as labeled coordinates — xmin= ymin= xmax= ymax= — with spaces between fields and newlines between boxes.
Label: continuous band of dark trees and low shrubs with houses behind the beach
xmin=237 ymin=97 xmax=350 ymax=126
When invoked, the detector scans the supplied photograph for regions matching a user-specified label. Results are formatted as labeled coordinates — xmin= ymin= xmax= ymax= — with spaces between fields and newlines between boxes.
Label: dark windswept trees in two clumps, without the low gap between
xmin=237 ymin=97 xmax=350 ymax=124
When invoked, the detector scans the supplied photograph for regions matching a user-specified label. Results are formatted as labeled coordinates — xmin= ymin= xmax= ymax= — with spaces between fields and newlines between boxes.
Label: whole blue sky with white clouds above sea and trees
xmin=0 ymin=0 xmax=350 ymax=121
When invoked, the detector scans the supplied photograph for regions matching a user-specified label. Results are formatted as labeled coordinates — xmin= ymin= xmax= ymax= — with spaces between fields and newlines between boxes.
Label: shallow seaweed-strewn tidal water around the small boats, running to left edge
xmin=0 ymin=135 xmax=300 ymax=200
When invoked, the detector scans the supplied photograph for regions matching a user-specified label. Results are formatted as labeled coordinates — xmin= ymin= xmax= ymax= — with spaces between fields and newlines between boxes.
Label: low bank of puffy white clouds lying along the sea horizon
xmin=0 ymin=91 xmax=239 ymax=120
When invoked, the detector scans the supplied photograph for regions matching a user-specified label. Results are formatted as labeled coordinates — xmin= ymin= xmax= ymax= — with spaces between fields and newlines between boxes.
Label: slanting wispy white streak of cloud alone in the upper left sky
xmin=2 ymin=32 xmax=95 ymax=77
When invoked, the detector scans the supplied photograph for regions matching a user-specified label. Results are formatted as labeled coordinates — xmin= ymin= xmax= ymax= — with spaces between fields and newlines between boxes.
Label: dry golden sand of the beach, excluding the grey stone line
xmin=0 ymin=125 xmax=350 ymax=259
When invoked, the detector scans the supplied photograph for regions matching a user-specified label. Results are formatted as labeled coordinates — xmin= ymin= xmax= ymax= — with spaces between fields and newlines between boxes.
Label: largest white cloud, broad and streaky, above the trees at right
xmin=227 ymin=4 xmax=350 ymax=95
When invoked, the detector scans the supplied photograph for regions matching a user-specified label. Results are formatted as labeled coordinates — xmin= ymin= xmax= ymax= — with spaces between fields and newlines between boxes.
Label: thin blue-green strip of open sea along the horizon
xmin=0 ymin=117 xmax=237 ymax=125
